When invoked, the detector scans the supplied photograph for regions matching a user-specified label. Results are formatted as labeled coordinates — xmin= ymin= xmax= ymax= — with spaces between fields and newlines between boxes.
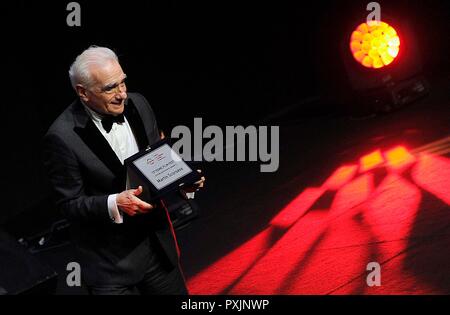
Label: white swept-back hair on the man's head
xmin=69 ymin=45 xmax=119 ymax=90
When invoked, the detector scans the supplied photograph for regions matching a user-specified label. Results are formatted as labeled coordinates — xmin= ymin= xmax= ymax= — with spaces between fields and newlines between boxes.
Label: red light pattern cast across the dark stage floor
xmin=188 ymin=146 xmax=450 ymax=294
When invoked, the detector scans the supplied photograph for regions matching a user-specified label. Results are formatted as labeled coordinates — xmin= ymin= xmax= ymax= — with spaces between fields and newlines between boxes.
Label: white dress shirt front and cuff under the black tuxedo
xmin=84 ymin=104 xmax=139 ymax=223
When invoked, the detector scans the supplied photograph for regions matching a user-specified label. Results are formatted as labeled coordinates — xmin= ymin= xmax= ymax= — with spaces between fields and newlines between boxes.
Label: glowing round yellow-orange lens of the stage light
xmin=350 ymin=21 xmax=400 ymax=68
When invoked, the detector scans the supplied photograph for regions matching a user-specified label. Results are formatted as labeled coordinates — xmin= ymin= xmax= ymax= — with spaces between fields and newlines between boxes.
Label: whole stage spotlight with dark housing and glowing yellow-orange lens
xmin=335 ymin=14 xmax=429 ymax=115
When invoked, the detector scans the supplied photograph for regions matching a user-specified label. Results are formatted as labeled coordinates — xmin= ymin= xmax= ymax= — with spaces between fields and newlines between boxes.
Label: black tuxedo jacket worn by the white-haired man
xmin=44 ymin=93 xmax=179 ymax=285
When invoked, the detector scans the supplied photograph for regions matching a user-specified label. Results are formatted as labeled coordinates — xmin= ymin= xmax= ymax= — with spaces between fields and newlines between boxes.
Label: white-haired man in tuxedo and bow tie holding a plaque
xmin=44 ymin=46 xmax=204 ymax=294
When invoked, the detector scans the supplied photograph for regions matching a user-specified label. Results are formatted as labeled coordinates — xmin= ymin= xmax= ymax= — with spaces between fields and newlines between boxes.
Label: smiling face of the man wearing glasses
xmin=77 ymin=61 xmax=127 ymax=116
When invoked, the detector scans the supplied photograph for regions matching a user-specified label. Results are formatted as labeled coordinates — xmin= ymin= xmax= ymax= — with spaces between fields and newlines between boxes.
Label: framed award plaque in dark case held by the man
xmin=125 ymin=139 xmax=200 ymax=201
